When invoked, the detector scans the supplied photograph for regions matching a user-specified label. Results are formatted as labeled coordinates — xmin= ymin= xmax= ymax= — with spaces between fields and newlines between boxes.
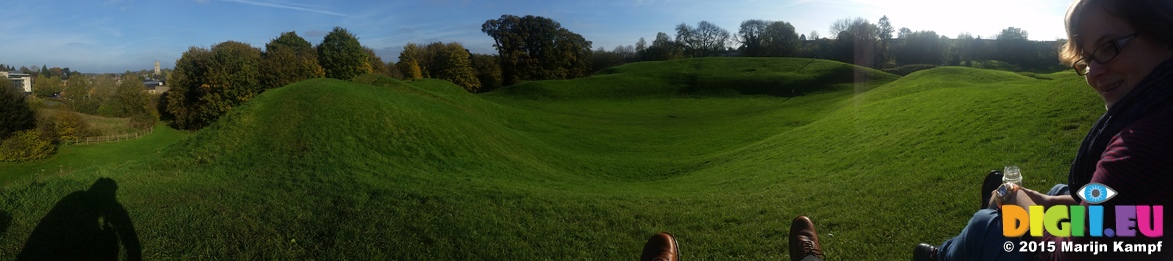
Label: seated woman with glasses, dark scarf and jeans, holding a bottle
xmin=913 ymin=0 xmax=1173 ymax=260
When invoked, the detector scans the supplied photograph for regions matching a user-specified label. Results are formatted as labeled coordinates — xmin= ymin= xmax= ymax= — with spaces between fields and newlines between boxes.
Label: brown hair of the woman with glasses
xmin=1059 ymin=0 xmax=1173 ymax=64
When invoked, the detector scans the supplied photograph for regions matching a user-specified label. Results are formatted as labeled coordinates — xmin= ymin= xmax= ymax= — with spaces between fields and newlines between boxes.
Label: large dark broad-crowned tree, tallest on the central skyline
xmin=481 ymin=15 xmax=591 ymax=85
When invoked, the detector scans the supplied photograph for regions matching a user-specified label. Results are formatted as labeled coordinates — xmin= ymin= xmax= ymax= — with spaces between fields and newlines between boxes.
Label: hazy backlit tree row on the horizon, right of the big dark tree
xmin=591 ymin=16 xmax=1063 ymax=71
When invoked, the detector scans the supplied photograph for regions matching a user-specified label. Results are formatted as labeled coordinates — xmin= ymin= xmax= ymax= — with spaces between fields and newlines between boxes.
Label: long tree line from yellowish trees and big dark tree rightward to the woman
xmin=394 ymin=14 xmax=1063 ymax=97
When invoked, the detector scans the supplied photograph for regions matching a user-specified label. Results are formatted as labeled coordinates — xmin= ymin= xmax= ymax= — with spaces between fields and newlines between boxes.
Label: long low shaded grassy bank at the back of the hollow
xmin=485 ymin=57 xmax=897 ymax=99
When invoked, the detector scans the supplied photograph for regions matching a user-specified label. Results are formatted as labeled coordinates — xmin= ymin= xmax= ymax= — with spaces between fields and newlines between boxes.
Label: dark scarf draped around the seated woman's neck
xmin=1067 ymin=60 xmax=1173 ymax=202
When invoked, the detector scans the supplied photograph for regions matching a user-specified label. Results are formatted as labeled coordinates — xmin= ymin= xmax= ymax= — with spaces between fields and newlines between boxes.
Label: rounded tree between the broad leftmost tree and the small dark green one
xmin=260 ymin=32 xmax=326 ymax=89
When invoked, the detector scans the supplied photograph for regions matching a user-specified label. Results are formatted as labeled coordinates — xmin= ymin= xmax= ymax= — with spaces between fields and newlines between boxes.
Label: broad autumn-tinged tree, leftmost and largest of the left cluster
xmin=163 ymin=41 xmax=262 ymax=130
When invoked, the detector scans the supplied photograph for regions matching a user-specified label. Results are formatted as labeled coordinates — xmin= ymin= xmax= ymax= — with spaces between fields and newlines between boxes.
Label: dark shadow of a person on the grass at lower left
xmin=16 ymin=178 xmax=142 ymax=260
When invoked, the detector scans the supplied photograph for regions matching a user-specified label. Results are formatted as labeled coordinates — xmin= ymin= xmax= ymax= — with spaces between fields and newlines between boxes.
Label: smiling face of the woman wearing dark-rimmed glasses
xmin=1077 ymin=7 xmax=1173 ymax=108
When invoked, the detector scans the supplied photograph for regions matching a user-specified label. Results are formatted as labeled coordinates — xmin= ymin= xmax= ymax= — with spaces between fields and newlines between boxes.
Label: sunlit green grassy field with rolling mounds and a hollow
xmin=0 ymin=59 xmax=1103 ymax=260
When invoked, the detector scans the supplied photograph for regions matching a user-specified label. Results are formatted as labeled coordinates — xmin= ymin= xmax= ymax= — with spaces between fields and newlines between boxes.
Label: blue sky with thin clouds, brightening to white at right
xmin=0 ymin=0 xmax=1070 ymax=73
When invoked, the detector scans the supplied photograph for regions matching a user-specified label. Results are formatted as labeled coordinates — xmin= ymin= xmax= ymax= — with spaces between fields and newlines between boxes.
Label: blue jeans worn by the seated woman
xmin=937 ymin=184 xmax=1071 ymax=261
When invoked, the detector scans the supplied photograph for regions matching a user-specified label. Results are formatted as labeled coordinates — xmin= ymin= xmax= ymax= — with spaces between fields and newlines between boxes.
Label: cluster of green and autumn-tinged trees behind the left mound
xmin=158 ymin=27 xmax=391 ymax=130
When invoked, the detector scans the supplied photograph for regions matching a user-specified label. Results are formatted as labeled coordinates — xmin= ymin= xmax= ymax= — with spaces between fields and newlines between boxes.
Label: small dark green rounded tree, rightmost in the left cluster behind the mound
xmin=318 ymin=27 xmax=371 ymax=80
